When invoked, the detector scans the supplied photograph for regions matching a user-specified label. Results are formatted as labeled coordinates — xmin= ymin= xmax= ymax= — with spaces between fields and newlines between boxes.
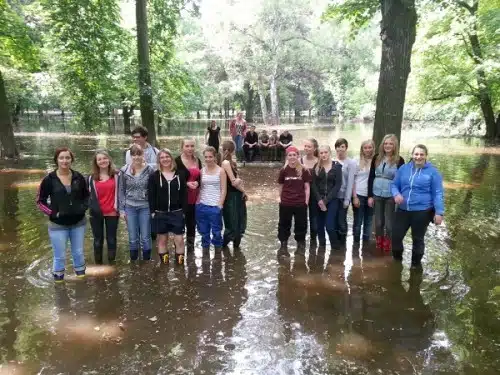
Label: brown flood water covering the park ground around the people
xmin=0 ymin=125 xmax=500 ymax=375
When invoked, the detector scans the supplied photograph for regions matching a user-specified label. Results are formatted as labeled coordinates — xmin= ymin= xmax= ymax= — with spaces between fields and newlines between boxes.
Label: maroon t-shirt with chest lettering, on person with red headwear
xmin=278 ymin=165 xmax=311 ymax=206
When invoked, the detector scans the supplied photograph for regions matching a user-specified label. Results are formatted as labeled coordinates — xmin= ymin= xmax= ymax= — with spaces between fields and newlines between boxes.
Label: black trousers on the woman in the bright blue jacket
xmin=392 ymin=209 xmax=434 ymax=265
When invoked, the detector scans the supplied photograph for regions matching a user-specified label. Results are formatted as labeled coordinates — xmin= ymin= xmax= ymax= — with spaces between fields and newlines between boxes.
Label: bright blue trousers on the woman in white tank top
xmin=195 ymin=203 xmax=223 ymax=249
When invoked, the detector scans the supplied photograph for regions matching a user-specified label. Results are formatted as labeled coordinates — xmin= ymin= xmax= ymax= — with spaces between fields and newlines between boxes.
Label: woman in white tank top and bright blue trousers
xmin=196 ymin=147 xmax=227 ymax=257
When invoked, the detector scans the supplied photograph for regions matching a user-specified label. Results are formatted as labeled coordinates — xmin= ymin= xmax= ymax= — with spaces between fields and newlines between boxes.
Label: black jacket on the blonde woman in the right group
xmin=311 ymin=161 xmax=342 ymax=204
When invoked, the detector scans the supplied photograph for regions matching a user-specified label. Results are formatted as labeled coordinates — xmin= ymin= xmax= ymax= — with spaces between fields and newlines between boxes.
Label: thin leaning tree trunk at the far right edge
xmin=463 ymin=0 xmax=500 ymax=139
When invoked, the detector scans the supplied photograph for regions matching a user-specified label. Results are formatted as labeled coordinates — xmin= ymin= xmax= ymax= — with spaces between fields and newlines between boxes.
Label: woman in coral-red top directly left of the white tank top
xmin=175 ymin=138 xmax=201 ymax=253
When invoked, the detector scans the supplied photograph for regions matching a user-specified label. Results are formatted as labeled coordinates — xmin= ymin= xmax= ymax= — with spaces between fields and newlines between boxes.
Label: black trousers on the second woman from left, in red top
xmin=90 ymin=216 xmax=119 ymax=264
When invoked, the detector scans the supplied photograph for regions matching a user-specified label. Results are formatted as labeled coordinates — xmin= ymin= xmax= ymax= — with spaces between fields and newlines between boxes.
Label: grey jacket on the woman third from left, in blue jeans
xmin=118 ymin=164 xmax=154 ymax=213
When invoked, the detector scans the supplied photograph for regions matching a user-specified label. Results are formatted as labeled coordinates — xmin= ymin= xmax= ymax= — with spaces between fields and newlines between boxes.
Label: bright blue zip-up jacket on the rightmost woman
xmin=391 ymin=161 xmax=444 ymax=215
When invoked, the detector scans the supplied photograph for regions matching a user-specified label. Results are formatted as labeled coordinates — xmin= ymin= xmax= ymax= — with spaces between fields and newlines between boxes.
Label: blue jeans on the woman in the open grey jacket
xmin=125 ymin=206 xmax=152 ymax=260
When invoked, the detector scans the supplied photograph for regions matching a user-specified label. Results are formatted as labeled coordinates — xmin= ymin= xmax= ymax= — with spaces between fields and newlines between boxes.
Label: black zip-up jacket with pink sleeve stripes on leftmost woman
xmin=36 ymin=170 xmax=89 ymax=226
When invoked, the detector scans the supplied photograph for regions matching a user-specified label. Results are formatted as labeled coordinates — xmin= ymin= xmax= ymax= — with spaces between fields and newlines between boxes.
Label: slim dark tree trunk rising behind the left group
xmin=135 ymin=0 xmax=156 ymax=145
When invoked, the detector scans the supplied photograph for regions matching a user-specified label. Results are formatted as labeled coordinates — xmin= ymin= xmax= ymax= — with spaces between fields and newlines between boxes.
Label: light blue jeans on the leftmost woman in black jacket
xmin=49 ymin=225 xmax=85 ymax=275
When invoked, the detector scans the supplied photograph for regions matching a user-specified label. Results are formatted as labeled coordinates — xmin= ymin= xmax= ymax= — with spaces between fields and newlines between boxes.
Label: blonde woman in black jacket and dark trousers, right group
xmin=311 ymin=146 xmax=342 ymax=251
